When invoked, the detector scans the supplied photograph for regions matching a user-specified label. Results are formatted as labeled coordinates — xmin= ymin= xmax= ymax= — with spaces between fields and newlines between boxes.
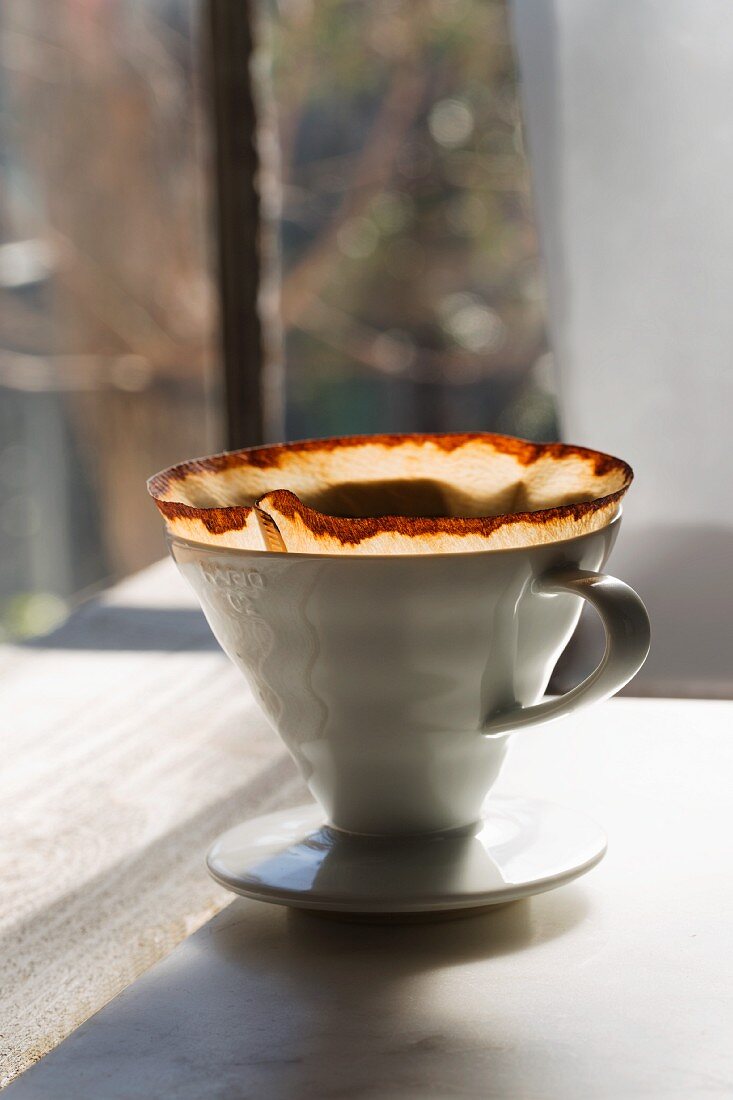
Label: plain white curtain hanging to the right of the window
xmin=513 ymin=0 xmax=733 ymax=696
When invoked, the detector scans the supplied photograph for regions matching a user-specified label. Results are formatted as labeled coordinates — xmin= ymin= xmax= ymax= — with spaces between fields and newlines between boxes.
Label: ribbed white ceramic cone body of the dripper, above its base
xmin=172 ymin=520 xmax=646 ymax=834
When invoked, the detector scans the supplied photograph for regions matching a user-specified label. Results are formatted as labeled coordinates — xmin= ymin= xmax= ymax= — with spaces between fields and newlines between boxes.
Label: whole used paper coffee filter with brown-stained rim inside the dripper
xmin=149 ymin=432 xmax=633 ymax=554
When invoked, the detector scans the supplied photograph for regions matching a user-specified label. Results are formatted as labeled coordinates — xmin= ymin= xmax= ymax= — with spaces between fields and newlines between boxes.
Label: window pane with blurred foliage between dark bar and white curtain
xmin=265 ymin=0 xmax=557 ymax=439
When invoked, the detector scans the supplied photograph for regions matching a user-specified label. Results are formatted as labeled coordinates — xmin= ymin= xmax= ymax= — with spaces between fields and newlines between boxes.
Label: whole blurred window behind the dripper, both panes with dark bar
xmin=0 ymin=0 xmax=548 ymax=637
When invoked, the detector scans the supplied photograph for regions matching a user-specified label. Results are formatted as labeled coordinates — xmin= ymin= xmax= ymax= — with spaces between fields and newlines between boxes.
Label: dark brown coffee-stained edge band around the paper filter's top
xmin=147 ymin=431 xmax=634 ymax=543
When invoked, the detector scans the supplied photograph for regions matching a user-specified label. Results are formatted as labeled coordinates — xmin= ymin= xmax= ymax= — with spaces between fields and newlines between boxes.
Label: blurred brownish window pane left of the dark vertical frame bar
xmin=0 ymin=0 xmax=220 ymax=636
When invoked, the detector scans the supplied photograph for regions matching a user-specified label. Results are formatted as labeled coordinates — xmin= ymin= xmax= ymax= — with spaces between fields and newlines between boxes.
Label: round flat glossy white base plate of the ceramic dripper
xmin=207 ymin=796 xmax=606 ymax=920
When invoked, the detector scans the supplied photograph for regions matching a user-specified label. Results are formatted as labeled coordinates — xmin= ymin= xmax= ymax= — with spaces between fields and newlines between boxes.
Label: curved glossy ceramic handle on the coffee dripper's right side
xmin=482 ymin=565 xmax=650 ymax=736
